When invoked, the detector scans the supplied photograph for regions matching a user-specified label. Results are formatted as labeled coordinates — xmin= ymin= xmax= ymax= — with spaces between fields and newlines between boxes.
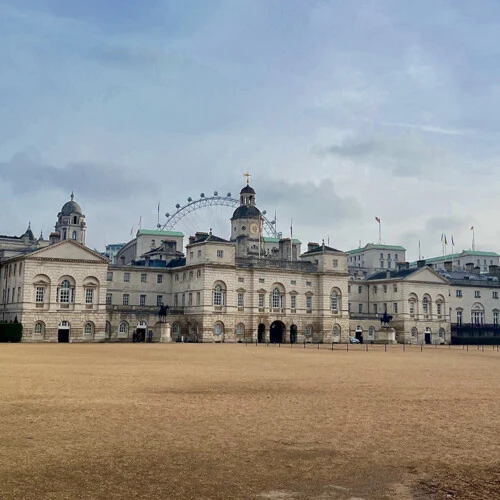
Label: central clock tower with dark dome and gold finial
xmin=231 ymin=179 xmax=262 ymax=256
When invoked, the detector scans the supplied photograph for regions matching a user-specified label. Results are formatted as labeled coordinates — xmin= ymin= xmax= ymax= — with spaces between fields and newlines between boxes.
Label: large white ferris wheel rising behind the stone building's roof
xmin=157 ymin=191 xmax=278 ymax=238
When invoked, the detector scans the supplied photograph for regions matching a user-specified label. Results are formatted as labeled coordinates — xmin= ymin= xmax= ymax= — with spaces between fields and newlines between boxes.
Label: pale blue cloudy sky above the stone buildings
xmin=0 ymin=0 xmax=500 ymax=260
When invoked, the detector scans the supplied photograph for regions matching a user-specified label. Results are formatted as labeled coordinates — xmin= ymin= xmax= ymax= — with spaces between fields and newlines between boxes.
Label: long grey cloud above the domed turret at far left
xmin=0 ymin=149 xmax=144 ymax=200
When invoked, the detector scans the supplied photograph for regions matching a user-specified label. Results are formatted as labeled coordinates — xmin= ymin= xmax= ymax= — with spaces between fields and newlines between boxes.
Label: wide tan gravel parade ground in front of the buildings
xmin=0 ymin=344 xmax=500 ymax=500
